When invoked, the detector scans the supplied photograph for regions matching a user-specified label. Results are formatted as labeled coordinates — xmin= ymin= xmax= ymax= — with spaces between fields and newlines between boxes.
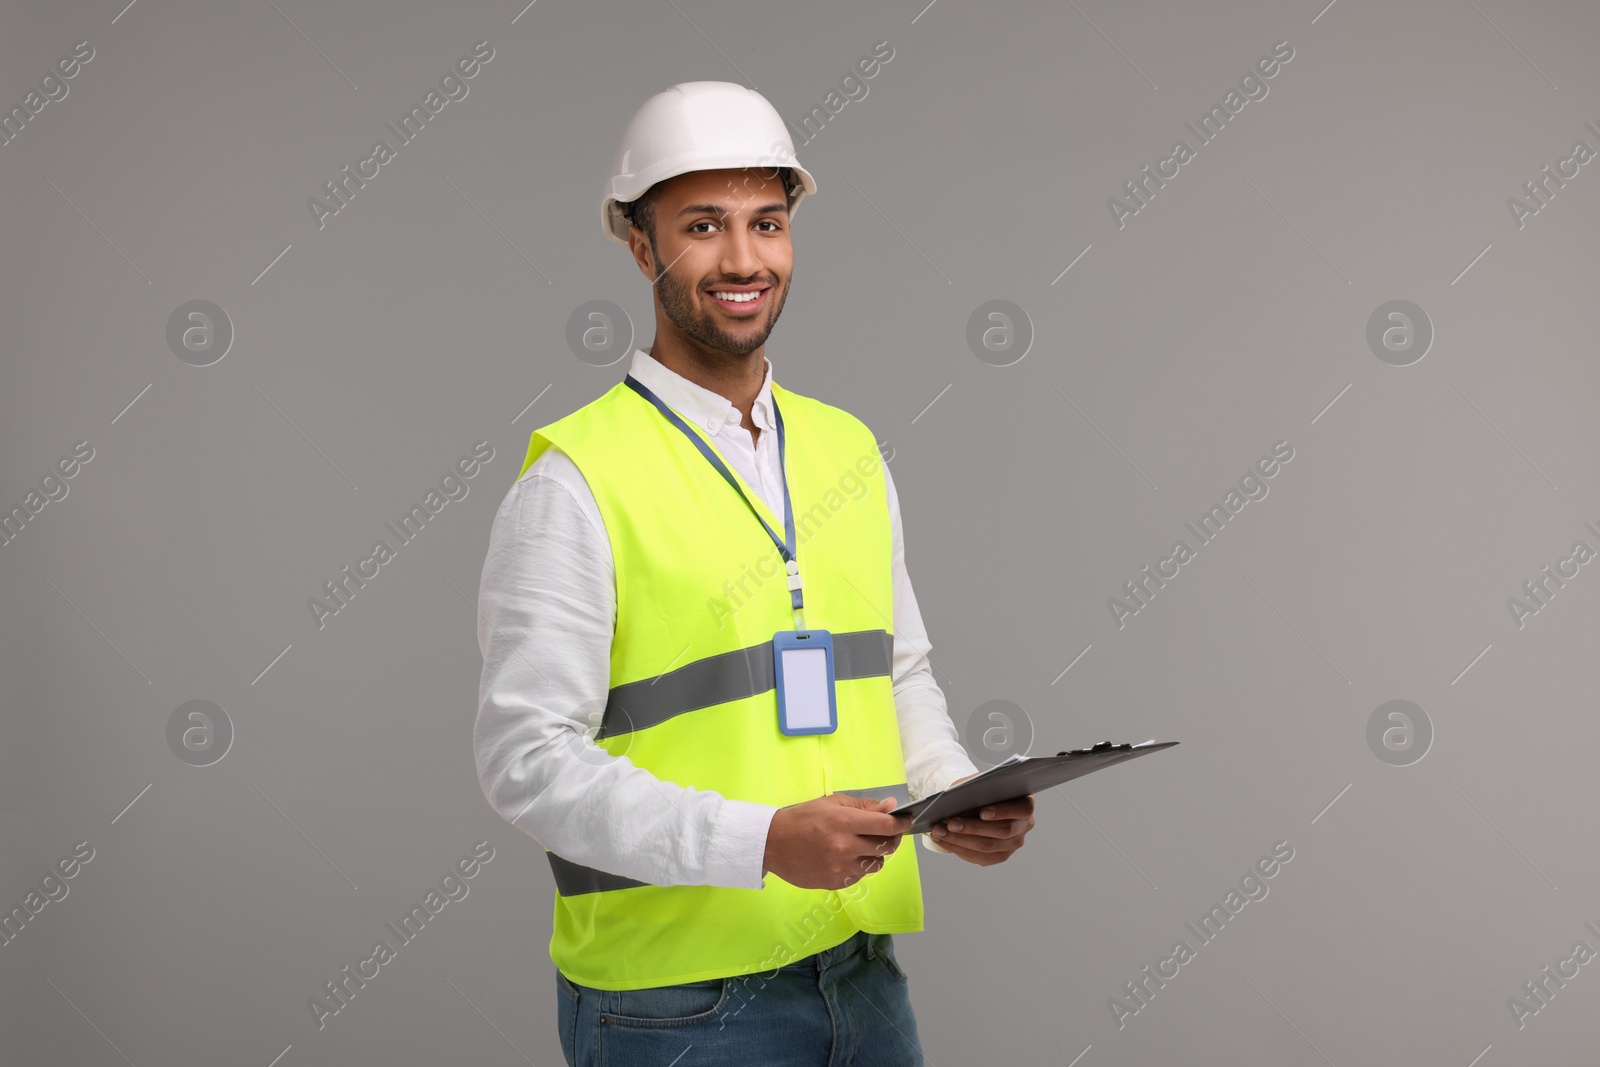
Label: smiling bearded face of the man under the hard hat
xmin=629 ymin=168 xmax=794 ymax=357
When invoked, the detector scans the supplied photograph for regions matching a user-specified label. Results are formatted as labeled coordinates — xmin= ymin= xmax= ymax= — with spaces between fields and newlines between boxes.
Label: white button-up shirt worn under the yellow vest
xmin=472 ymin=349 xmax=978 ymax=889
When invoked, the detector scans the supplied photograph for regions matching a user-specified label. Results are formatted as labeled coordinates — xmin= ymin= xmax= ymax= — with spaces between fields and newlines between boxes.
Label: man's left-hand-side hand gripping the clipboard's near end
xmin=762 ymin=793 xmax=906 ymax=889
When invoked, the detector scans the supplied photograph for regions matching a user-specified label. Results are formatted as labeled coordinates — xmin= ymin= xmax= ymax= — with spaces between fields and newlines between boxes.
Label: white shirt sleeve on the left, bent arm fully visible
xmin=472 ymin=448 xmax=778 ymax=889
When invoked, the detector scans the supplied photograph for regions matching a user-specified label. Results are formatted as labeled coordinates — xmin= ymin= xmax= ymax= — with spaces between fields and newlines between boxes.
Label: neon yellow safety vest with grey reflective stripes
xmin=522 ymin=382 xmax=923 ymax=989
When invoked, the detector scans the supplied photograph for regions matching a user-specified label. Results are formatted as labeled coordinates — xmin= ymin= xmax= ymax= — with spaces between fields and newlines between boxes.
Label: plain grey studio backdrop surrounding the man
xmin=0 ymin=0 xmax=1600 ymax=1067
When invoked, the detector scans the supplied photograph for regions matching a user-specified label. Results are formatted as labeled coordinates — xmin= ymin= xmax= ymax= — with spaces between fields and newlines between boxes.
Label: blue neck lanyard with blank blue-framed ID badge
xmin=622 ymin=374 xmax=838 ymax=736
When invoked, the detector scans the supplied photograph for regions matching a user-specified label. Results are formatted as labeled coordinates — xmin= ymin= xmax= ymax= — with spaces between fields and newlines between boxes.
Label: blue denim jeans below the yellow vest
xmin=555 ymin=931 xmax=923 ymax=1067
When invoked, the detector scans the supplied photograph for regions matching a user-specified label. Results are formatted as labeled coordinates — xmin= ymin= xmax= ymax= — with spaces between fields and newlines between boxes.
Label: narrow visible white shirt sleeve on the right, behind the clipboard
xmin=883 ymin=464 xmax=978 ymax=853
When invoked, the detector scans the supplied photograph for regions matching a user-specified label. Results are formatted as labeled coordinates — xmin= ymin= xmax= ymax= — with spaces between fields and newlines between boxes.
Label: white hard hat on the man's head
xmin=600 ymin=82 xmax=816 ymax=246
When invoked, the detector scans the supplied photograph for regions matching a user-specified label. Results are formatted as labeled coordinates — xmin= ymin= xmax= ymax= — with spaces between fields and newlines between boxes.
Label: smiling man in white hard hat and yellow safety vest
xmin=474 ymin=82 xmax=1034 ymax=1067
